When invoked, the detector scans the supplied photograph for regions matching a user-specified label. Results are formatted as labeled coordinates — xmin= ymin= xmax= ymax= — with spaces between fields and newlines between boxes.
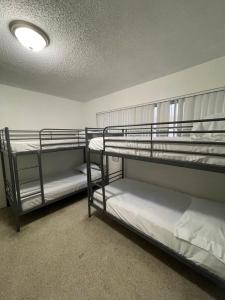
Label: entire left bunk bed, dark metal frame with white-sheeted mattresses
xmin=0 ymin=127 xmax=87 ymax=231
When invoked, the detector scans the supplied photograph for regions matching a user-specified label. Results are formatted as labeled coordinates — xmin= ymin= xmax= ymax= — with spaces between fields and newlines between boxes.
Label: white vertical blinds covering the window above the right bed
xmin=96 ymin=87 xmax=225 ymax=128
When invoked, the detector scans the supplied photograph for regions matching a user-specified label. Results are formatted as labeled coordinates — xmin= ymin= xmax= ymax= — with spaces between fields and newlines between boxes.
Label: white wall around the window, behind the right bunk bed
xmin=83 ymin=56 xmax=225 ymax=201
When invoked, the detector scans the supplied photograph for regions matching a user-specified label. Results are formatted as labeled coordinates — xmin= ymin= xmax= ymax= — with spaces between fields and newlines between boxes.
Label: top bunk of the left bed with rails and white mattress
xmin=0 ymin=127 xmax=85 ymax=154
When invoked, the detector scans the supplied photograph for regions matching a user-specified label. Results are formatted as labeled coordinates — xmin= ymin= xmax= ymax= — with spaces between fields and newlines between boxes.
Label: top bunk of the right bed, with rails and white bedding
xmin=86 ymin=116 xmax=225 ymax=173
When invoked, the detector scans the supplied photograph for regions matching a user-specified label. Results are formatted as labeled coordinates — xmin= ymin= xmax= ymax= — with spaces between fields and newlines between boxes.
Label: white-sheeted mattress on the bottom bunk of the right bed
xmin=94 ymin=179 xmax=225 ymax=279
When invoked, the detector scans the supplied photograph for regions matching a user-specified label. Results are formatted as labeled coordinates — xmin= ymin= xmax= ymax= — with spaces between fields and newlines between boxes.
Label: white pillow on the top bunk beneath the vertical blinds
xmin=191 ymin=113 xmax=225 ymax=138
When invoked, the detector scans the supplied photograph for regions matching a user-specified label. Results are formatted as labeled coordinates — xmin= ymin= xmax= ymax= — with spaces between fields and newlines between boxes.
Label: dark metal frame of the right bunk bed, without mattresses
xmin=85 ymin=118 xmax=225 ymax=288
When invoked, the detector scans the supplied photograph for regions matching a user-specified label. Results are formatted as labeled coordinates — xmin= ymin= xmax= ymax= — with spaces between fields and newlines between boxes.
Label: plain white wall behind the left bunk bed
xmin=0 ymin=85 xmax=84 ymax=207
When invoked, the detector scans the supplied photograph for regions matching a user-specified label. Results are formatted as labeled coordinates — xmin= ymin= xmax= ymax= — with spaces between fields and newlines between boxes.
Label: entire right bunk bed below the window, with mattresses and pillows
xmin=86 ymin=117 xmax=225 ymax=286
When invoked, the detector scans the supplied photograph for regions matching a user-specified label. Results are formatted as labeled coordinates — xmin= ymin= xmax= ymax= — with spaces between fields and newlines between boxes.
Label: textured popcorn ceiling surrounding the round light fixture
xmin=0 ymin=0 xmax=225 ymax=101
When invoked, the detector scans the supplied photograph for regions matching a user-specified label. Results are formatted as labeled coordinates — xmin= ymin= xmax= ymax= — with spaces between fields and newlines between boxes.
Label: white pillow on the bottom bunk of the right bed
xmin=174 ymin=198 xmax=225 ymax=264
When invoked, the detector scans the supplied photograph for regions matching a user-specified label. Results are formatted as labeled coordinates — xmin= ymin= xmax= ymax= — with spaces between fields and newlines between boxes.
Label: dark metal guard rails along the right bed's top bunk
xmin=103 ymin=118 xmax=225 ymax=173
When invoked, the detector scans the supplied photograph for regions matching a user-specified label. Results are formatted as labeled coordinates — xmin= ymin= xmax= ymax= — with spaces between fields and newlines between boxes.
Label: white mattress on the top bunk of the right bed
xmin=89 ymin=136 xmax=225 ymax=165
